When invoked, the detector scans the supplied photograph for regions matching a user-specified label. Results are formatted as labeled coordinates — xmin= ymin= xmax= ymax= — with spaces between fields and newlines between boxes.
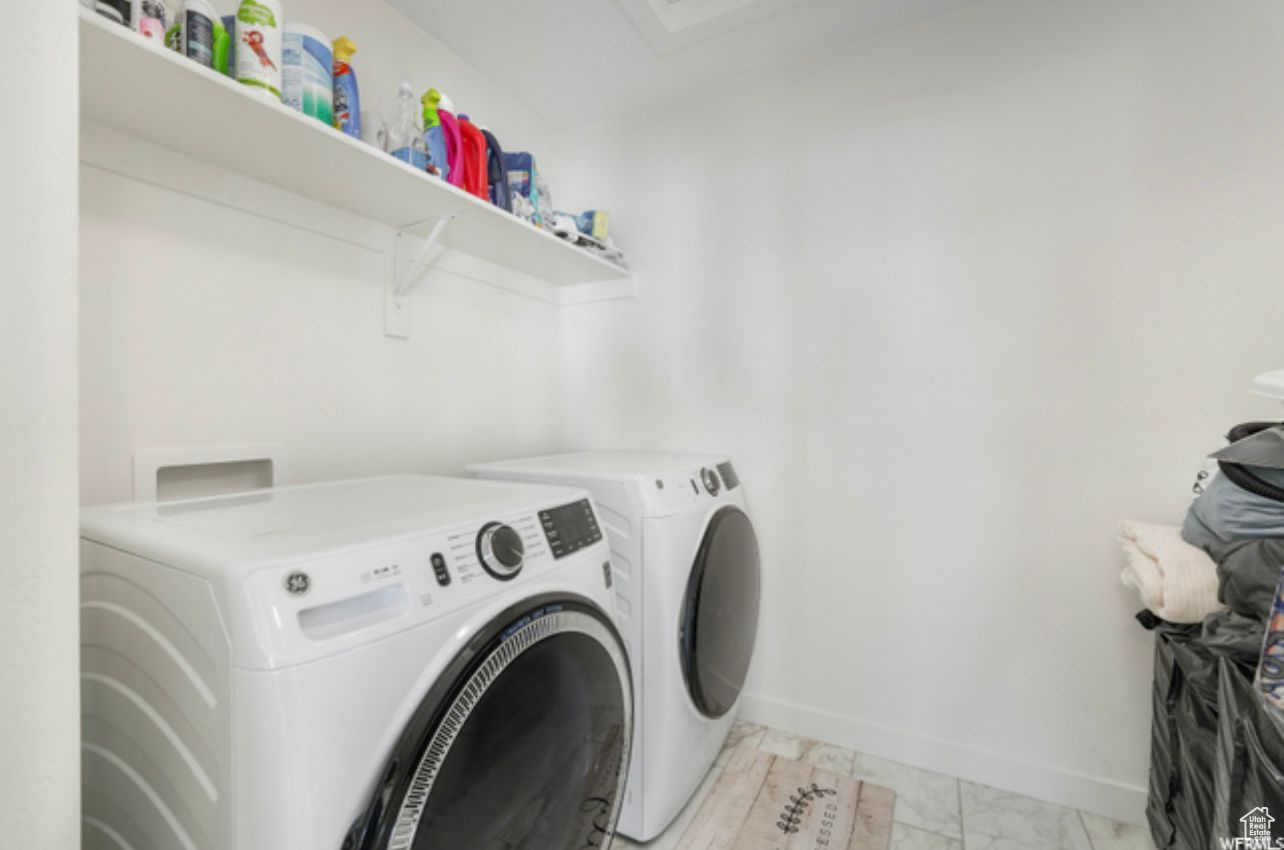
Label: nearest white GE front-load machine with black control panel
xmin=81 ymin=476 xmax=632 ymax=850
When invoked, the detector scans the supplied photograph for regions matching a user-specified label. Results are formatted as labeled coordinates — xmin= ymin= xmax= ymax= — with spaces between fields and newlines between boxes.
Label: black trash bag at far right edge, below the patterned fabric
xmin=1212 ymin=659 xmax=1284 ymax=846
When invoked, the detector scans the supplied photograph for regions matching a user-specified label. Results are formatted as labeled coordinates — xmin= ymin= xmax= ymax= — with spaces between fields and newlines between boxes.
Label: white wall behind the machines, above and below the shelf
xmin=81 ymin=0 xmax=559 ymax=503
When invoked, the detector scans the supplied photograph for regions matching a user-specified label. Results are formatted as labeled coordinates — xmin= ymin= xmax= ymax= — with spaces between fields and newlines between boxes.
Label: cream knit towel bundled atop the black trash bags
xmin=1120 ymin=520 xmax=1224 ymax=623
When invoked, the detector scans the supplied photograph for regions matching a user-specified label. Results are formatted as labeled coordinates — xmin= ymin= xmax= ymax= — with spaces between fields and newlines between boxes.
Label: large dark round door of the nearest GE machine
xmin=344 ymin=597 xmax=633 ymax=850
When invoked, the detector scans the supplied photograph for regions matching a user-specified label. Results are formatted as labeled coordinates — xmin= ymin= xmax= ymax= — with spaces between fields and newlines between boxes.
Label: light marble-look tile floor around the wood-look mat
xmin=615 ymin=723 xmax=1154 ymax=850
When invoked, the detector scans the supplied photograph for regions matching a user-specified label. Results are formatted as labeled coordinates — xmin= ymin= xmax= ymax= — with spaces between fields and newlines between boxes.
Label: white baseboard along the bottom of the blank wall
xmin=740 ymin=693 xmax=1145 ymax=824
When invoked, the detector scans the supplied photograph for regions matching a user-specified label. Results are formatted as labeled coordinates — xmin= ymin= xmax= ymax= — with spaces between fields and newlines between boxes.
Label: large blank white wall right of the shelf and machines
xmin=560 ymin=0 xmax=1284 ymax=819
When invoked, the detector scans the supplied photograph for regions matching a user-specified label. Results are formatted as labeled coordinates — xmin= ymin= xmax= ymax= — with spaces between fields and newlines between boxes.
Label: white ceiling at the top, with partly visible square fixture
xmin=390 ymin=0 xmax=972 ymax=128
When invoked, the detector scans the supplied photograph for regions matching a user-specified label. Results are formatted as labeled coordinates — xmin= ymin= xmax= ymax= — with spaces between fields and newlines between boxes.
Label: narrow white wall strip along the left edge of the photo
xmin=0 ymin=3 xmax=80 ymax=850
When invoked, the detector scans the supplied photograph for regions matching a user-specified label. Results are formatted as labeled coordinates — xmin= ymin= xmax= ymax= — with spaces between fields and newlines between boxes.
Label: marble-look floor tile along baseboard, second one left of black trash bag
xmin=959 ymin=782 xmax=1091 ymax=850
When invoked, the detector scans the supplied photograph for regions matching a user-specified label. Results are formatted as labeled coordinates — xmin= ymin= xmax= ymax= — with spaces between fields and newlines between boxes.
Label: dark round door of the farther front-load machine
xmin=679 ymin=506 xmax=761 ymax=719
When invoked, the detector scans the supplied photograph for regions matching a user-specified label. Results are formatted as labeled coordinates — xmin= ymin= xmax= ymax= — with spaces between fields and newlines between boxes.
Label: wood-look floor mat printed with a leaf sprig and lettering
xmin=678 ymin=747 xmax=896 ymax=850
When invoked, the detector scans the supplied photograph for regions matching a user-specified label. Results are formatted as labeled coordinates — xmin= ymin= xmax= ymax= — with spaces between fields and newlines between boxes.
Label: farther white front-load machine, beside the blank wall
xmin=469 ymin=452 xmax=760 ymax=841
